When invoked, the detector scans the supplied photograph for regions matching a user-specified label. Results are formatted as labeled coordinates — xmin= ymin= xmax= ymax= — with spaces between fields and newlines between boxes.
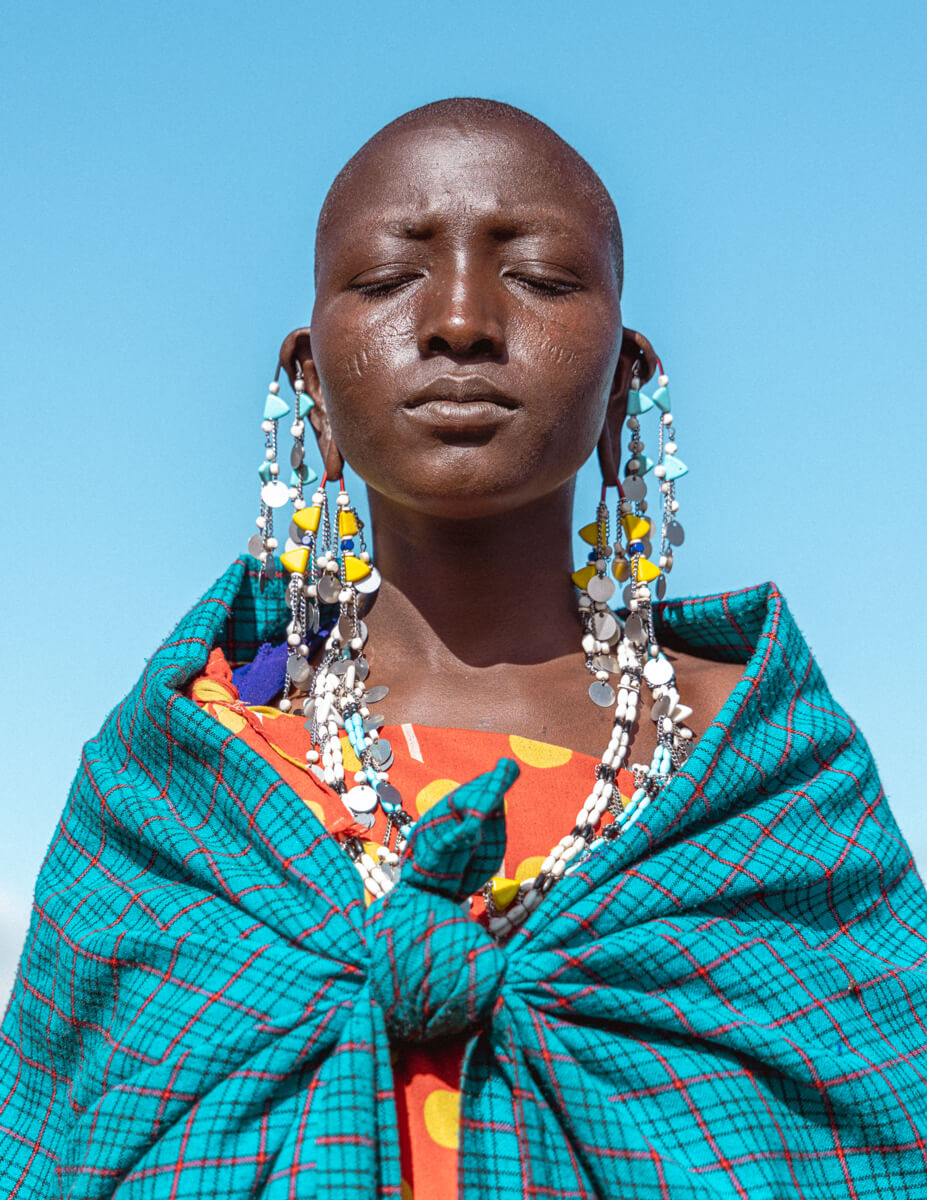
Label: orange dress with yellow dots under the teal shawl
xmin=186 ymin=648 xmax=634 ymax=1200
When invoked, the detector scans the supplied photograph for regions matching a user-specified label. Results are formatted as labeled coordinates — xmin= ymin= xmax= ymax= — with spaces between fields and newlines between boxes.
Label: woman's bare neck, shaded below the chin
xmin=365 ymin=480 xmax=580 ymax=667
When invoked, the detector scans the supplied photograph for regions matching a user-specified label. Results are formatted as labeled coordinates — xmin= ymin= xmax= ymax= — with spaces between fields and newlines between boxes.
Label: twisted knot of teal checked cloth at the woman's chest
xmin=365 ymin=758 xmax=518 ymax=1042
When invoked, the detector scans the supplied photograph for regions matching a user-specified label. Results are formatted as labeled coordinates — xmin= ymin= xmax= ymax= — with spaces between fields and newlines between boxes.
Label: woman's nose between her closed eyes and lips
xmin=419 ymin=271 xmax=506 ymax=361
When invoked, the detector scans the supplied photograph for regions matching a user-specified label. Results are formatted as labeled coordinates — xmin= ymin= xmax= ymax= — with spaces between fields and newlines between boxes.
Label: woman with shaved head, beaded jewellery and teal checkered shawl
xmin=0 ymin=101 xmax=927 ymax=1200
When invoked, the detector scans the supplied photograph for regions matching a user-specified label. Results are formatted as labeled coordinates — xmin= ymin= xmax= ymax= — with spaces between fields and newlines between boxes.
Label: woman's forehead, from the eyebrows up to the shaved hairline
xmin=319 ymin=122 xmax=610 ymax=254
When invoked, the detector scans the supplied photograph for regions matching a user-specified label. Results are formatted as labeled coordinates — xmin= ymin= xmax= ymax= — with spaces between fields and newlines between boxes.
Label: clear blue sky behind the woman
xmin=0 ymin=0 xmax=927 ymax=990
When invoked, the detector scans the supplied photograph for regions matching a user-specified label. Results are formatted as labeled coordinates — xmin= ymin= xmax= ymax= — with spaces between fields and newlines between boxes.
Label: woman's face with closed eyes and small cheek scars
xmin=304 ymin=117 xmax=622 ymax=518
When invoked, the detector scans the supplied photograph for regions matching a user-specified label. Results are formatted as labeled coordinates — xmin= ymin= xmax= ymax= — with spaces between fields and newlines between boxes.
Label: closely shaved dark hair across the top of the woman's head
xmin=316 ymin=97 xmax=623 ymax=292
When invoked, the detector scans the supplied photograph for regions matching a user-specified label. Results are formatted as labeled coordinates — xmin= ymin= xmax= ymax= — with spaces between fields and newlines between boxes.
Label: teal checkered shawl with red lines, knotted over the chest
xmin=0 ymin=559 xmax=927 ymax=1200
